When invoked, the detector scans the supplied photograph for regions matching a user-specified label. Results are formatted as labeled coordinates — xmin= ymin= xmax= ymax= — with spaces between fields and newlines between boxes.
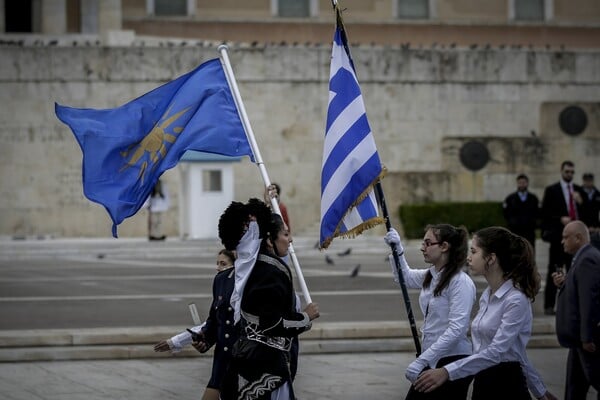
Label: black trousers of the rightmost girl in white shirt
xmin=471 ymin=361 xmax=531 ymax=400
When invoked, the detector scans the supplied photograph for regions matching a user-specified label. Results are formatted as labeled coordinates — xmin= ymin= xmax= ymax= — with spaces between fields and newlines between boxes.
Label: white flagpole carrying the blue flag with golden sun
xmin=217 ymin=44 xmax=312 ymax=304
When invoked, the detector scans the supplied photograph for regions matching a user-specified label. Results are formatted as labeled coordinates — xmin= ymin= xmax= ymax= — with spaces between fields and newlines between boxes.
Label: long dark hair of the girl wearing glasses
xmin=423 ymin=224 xmax=469 ymax=296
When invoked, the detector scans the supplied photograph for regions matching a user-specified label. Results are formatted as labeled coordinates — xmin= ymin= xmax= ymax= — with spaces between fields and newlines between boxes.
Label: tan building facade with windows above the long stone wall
xmin=0 ymin=0 xmax=600 ymax=48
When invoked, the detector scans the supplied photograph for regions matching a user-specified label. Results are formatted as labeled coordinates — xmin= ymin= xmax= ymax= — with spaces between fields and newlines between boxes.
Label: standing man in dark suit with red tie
xmin=542 ymin=161 xmax=583 ymax=315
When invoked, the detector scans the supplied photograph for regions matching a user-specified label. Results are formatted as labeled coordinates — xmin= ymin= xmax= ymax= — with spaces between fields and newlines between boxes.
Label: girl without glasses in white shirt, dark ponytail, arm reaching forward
xmin=414 ymin=227 xmax=556 ymax=400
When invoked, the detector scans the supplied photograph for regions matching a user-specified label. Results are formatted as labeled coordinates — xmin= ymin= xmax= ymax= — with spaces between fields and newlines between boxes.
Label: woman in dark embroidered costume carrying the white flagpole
xmin=219 ymin=199 xmax=319 ymax=400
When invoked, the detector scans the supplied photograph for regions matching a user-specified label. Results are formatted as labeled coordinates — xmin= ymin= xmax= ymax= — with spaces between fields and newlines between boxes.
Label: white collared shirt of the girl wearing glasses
xmin=401 ymin=263 xmax=476 ymax=368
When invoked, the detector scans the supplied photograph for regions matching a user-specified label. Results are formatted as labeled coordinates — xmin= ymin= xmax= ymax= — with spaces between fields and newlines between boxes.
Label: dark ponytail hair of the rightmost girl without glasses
xmin=474 ymin=226 xmax=541 ymax=302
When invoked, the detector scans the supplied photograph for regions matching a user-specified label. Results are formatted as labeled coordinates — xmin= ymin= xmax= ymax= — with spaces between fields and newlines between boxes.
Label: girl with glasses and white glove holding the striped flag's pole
xmin=385 ymin=224 xmax=476 ymax=400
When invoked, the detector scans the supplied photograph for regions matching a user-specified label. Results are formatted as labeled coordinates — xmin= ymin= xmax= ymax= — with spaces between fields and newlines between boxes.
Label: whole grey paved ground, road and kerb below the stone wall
xmin=0 ymin=235 xmax=596 ymax=400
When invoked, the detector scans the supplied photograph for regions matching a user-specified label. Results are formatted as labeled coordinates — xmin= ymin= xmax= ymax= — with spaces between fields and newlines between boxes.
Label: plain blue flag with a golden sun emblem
xmin=55 ymin=59 xmax=254 ymax=237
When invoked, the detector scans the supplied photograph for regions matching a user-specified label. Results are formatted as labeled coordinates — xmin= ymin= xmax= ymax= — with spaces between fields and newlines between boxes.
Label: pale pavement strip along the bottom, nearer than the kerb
xmin=0 ymin=348 xmax=596 ymax=400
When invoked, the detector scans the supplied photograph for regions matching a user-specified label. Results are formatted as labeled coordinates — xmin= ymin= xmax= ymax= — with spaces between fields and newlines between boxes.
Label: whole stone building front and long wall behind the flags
xmin=0 ymin=0 xmax=600 ymax=237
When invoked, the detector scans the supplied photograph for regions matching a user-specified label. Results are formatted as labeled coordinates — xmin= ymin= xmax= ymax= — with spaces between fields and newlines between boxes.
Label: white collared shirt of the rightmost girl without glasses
xmin=444 ymin=279 xmax=546 ymax=398
